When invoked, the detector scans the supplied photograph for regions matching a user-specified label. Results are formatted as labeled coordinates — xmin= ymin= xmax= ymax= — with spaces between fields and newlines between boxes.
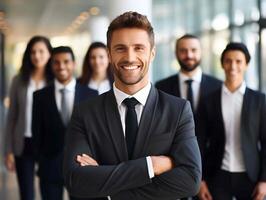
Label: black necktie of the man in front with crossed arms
xmin=123 ymin=97 xmax=139 ymax=158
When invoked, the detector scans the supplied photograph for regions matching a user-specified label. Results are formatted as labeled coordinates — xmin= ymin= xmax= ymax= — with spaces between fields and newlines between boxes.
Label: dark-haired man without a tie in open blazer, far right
xmin=198 ymin=43 xmax=266 ymax=200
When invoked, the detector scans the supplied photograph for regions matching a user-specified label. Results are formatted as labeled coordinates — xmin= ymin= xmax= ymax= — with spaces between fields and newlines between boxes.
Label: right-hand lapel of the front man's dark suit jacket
xmin=132 ymin=86 xmax=158 ymax=159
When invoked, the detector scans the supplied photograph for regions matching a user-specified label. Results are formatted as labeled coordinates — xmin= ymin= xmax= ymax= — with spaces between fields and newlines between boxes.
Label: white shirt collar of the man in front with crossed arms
xmin=113 ymin=83 xmax=151 ymax=106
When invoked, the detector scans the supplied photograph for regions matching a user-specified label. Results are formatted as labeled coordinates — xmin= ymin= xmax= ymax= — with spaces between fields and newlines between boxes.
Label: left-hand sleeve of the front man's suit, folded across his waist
xmin=63 ymin=106 xmax=151 ymax=198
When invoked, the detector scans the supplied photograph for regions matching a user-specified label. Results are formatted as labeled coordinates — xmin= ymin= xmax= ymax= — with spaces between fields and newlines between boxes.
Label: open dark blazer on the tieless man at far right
xmin=198 ymin=88 xmax=266 ymax=182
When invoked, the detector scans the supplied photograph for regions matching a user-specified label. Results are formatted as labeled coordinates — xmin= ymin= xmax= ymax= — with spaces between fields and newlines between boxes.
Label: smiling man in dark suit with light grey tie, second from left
xmin=32 ymin=46 xmax=97 ymax=200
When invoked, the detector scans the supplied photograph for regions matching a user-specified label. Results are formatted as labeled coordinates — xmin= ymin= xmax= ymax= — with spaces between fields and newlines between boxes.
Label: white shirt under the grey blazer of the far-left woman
xmin=24 ymin=79 xmax=45 ymax=138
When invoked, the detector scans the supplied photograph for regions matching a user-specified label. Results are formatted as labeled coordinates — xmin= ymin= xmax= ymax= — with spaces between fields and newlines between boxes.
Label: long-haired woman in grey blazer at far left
xmin=5 ymin=36 xmax=53 ymax=200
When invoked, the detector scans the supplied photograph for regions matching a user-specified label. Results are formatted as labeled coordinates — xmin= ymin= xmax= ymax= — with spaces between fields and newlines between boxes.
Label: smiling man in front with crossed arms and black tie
xmin=64 ymin=12 xmax=201 ymax=200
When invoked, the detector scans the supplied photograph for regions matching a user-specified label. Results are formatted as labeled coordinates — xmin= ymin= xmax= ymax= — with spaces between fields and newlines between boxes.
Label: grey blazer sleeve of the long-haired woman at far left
xmin=5 ymin=76 xmax=18 ymax=154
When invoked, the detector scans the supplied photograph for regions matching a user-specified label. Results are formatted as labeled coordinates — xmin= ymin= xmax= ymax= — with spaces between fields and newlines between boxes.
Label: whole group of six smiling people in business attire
xmin=5 ymin=12 xmax=266 ymax=200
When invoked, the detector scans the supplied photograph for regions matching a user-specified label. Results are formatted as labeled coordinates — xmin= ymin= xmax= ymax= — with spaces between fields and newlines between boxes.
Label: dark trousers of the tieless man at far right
xmin=207 ymin=170 xmax=255 ymax=200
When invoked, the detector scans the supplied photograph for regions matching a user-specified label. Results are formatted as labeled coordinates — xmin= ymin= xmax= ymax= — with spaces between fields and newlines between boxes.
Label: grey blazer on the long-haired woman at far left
xmin=5 ymin=75 xmax=27 ymax=156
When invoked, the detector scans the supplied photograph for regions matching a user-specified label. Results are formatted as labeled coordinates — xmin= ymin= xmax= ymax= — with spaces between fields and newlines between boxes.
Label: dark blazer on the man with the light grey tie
xmin=32 ymin=83 xmax=98 ymax=181
